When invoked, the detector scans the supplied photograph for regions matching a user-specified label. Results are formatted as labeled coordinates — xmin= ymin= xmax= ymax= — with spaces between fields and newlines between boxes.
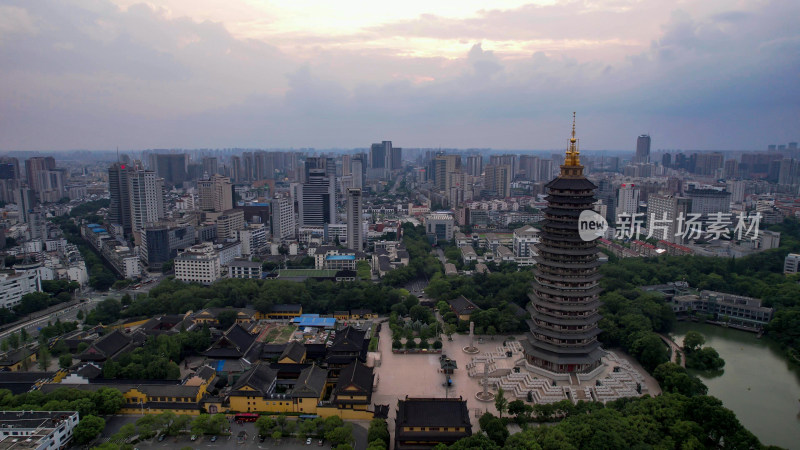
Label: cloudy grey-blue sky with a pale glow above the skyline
xmin=0 ymin=0 xmax=800 ymax=150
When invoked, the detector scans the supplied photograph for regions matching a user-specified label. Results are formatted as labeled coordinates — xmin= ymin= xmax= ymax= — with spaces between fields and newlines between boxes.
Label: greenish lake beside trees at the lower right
xmin=672 ymin=322 xmax=800 ymax=448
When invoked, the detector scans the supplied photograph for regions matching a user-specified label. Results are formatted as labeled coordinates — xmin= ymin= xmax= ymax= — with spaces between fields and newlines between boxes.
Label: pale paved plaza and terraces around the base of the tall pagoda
xmin=371 ymin=324 xmax=661 ymax=430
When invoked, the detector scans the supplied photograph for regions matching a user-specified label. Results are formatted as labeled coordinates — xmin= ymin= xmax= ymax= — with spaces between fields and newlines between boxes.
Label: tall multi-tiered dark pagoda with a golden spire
xmin=522 ymin=116 xmax=603 ymax=373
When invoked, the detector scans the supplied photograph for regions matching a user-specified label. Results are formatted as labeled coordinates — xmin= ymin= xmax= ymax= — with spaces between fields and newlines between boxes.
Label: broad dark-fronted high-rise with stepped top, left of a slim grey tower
xmin=298 ymin=168 xmax=336 ymax=226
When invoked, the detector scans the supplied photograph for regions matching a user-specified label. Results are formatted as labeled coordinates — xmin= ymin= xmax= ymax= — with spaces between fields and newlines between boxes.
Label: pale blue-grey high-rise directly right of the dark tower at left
xmin=128 ymin=170 xmax=164 ymax=232
